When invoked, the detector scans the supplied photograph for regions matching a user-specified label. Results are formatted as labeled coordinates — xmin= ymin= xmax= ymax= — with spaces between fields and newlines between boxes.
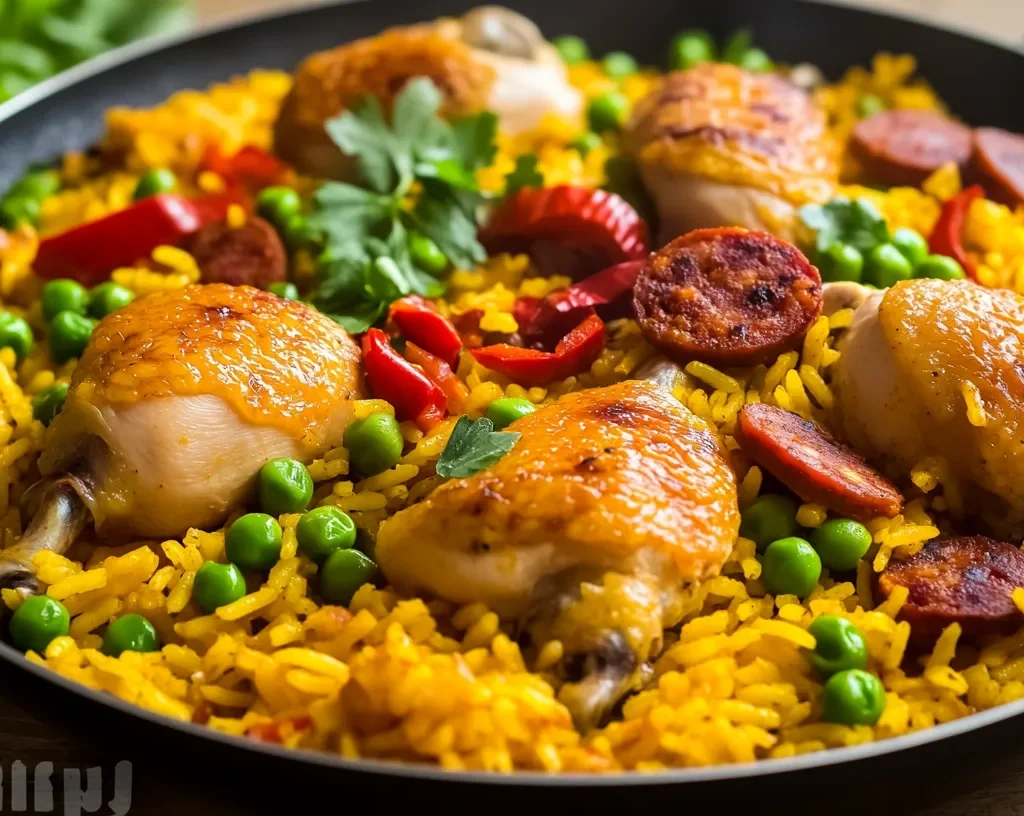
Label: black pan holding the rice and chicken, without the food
xmin=0 ymin=0 xmax=1024 ymax=813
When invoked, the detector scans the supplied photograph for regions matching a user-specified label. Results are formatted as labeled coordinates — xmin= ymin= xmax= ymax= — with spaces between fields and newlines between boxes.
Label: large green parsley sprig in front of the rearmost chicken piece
xmin=308 ymin=78 xmax=498 ymax=333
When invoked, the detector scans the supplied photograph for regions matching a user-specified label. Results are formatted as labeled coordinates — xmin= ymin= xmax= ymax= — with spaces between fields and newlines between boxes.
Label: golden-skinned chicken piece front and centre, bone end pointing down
xmin=376 ymin=381 xmax=739 ymax=727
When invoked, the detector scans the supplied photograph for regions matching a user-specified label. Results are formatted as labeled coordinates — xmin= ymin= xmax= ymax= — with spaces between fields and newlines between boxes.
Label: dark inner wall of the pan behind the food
xmin=0 ymin=0 xmax=1024 ymax=189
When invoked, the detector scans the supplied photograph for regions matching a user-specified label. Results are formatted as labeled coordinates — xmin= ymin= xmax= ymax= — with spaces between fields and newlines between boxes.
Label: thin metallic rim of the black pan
xmin=0 ymin=0 xmax=1024 ymax=788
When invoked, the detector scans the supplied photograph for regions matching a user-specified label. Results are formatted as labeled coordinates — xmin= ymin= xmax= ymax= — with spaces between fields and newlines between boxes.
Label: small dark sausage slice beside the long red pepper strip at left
xmin=190 ymin=217 xmax=288 ymax=289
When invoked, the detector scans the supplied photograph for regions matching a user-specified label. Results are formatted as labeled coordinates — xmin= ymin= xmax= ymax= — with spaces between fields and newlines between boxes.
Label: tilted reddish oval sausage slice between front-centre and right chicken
xmin=735 ymin=403 xmax=903 ymax=521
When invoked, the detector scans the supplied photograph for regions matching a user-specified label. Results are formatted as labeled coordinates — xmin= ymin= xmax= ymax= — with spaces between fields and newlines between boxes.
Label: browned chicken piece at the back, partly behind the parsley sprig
xmin=274 ymin=6 xmax=582 ymax=178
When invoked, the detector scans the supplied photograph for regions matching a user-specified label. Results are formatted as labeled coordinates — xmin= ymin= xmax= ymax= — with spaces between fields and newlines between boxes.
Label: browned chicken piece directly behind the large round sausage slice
xmin=626 ymin=63 xmax=839 ymax=244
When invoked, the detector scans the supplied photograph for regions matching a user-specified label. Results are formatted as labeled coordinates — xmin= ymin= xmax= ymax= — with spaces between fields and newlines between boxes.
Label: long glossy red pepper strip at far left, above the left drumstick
xmin=33 ymin=192 xmax=233 ymax=286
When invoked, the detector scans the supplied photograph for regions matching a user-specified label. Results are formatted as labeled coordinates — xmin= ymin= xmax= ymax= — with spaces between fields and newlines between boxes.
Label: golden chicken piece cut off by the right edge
xmin=833 ymin=281 xmax=1024 ymax=534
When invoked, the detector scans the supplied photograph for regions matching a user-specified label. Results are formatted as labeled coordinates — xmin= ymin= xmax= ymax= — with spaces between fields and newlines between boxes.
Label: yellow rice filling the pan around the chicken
xmin=0 ymin=50 xmax=1024 ymax=772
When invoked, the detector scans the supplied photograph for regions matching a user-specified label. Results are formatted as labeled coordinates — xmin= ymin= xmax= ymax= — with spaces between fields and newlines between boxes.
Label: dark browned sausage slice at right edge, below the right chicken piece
xmin=879 ymin=535 xmax=1024 ymax=635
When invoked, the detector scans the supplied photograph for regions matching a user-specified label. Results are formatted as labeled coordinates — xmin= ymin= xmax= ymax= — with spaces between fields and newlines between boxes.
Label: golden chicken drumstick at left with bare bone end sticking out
xmin=0 ymin=284 xmax=361 ymax=585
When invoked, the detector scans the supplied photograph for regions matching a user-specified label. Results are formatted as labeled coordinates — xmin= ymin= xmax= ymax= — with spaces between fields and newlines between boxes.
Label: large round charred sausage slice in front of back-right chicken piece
xmin=633 ymin=227 xmax=821 ymax=366
